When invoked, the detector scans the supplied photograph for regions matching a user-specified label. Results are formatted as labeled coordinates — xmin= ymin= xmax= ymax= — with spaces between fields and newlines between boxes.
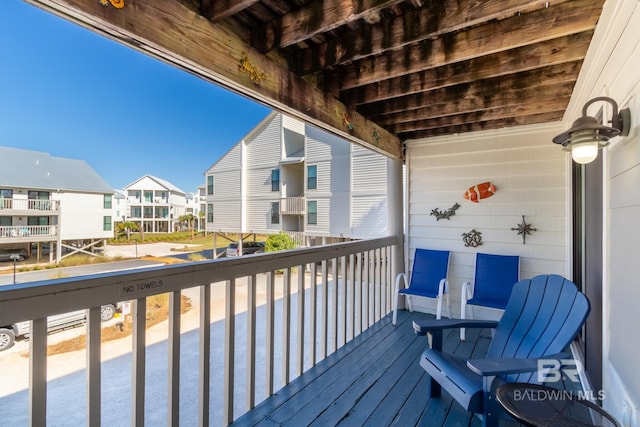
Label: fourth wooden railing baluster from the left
xmin=167 ymin=291 xmax=181 ymax=426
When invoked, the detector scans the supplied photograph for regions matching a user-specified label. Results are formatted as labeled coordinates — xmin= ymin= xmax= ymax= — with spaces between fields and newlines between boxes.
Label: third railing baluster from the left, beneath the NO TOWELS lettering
xmin=131 ymin=298 xmax=147 ymax=427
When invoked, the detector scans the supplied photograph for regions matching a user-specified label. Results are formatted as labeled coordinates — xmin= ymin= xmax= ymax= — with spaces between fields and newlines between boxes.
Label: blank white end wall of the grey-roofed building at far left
xmin=53 ymin=193 xmax=113 ymax=240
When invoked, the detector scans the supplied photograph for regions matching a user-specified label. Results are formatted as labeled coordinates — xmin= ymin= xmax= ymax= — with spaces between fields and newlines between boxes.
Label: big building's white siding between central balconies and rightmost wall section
xmin=305 ymin=125 xmax=351 ymax=236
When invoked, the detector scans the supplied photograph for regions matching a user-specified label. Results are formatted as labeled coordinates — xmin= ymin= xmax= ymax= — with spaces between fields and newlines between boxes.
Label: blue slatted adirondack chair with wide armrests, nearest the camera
xmin=413 ymin=275 xmax=590 ymax=427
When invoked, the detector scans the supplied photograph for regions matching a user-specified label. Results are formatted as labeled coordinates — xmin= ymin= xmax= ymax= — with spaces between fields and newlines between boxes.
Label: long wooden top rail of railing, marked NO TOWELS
xmin=0 ymin=236 xmax=398 ymax=325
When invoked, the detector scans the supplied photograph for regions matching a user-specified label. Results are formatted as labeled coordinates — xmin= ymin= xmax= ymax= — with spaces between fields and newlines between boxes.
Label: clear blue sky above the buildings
xmin=0 ymin=0 xmax=270 ymax=192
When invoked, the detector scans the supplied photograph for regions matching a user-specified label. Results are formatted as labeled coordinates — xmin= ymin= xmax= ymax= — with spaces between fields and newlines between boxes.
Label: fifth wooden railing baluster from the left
xmin=198 ymin=284 xmax=211 ymax=427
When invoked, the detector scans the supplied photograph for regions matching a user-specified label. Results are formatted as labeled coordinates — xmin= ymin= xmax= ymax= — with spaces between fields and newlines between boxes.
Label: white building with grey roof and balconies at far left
xmin=0 ymin=147 xmax=114 ymax=262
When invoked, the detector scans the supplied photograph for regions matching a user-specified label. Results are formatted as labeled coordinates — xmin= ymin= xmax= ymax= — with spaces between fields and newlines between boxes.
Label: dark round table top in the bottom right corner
xmin=496 ymin=383 xmax=619 ymax=427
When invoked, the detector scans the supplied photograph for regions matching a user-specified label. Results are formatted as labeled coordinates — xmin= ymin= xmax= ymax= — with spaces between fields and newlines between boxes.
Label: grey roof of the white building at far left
xmin=0 ymin=147 xmax=114 ymax=194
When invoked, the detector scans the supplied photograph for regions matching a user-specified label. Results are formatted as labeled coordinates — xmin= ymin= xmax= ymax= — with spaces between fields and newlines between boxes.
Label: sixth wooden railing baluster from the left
xmin=222 ymin=279 xmax=236 ymax=425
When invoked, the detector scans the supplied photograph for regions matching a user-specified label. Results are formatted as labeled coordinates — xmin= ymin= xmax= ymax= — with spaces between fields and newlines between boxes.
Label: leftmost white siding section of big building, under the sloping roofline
xmin=205 ymin=141 xmax=243 ymax=232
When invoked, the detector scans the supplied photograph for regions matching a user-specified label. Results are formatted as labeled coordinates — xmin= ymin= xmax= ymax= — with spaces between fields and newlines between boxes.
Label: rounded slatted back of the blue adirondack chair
xmin=487 ymin=275 xmax=590 ymax=382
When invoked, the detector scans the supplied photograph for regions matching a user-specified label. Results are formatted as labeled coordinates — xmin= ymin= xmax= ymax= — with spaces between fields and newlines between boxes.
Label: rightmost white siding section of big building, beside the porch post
xmin=351 ymin=144 xmax=388 ymax=238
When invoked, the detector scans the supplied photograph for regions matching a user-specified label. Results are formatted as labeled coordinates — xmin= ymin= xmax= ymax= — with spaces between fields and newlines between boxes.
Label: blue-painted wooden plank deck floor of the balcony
xmin=233 ymin=310 xmax=518 ymax=427
